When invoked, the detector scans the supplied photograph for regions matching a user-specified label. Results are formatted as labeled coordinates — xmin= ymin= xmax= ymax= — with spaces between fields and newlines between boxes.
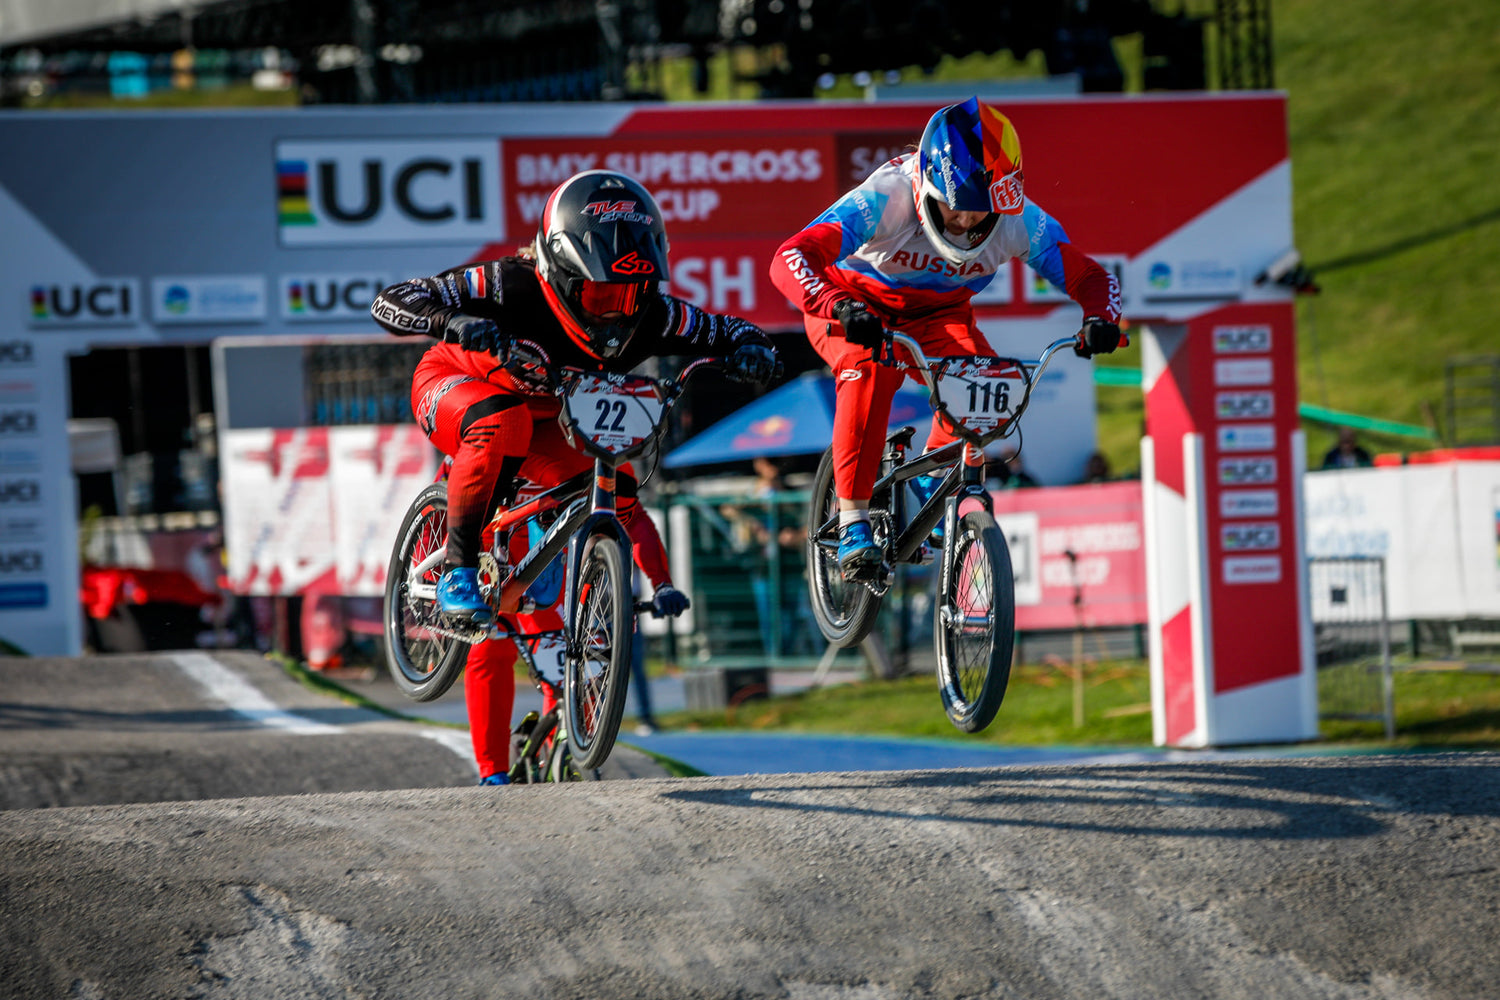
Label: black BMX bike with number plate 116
xmin=807 ymin=331 xmax=1076 ymax=733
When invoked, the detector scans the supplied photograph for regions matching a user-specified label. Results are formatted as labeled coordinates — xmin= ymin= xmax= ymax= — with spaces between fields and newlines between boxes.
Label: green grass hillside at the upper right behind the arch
xmin=1274 ymin=0 xmax=1500 ymax=456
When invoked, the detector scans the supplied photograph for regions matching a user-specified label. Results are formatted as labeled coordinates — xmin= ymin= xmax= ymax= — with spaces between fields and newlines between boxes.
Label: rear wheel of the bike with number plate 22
xmin=386 ymin=483 xmax=470 ymax=702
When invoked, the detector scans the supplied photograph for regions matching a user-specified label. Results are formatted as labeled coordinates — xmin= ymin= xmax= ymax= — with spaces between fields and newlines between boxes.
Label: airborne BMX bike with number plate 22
xmin=384 ymin=340 xmax=723 ymax=772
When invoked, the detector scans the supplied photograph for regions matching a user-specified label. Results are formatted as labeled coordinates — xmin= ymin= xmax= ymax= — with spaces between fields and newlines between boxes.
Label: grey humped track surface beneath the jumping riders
xmin=0 ymin=657 xmax=1500 ymax=1000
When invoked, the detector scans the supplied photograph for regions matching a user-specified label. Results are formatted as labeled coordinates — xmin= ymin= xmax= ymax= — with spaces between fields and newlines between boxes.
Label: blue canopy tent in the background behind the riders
xmin=663 ymin=372 xmax=932 ymax=469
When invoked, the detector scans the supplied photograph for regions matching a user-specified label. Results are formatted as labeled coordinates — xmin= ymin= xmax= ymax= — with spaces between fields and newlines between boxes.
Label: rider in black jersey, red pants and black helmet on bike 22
xmin=371 ymin=171 xmax=776 ymax=784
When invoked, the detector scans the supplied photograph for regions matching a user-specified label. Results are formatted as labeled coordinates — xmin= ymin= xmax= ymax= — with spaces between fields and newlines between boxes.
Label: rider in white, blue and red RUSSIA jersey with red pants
xmin=771 ymin=97 xmax=1121 ymax=579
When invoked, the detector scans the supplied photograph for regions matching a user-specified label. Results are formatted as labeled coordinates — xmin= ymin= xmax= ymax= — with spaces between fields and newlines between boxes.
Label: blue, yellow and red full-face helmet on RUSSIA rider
xmin=917 ymin=97 xmax=1023 ymax=264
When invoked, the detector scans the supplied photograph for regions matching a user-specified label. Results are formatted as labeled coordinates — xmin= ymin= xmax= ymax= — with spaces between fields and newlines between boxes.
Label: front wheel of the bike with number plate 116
xmin=933 ymin=511 xmax=1016 ymax=733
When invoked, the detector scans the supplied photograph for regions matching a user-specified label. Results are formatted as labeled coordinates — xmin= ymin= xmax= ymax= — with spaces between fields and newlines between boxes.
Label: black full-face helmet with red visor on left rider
xmin=536 ymin=169 xmax=671 ymax=360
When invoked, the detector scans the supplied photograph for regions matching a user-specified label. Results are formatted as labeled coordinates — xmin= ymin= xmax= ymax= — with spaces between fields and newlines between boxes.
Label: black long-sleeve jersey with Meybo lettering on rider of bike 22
xmin=371 ymin=256 xmax=771 ymax=381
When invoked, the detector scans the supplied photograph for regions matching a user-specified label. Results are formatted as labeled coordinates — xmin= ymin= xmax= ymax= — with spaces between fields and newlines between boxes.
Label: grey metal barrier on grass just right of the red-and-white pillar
xmin=1308 ymin=558 xmax=1395 ymax=739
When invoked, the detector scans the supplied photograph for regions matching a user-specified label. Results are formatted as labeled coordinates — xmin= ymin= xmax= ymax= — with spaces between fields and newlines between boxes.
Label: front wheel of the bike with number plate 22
xmin=564 ymin=535 xmax=635 ymax=771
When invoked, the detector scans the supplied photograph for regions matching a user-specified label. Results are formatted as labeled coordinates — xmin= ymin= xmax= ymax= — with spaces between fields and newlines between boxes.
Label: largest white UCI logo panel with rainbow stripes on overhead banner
xmin=276 ymin=139 xmax=506 ymax=246
